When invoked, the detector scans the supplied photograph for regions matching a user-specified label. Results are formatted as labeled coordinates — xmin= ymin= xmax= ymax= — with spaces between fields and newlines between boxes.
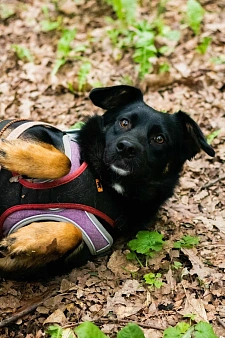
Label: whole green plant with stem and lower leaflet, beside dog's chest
xmin=127 ymin=230 xmax=164 ymax=266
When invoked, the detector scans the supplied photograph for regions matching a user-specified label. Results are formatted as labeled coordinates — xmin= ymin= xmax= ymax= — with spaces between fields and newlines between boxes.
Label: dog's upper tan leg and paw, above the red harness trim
xmin=0 ymin=140 xmax=71 ymax=179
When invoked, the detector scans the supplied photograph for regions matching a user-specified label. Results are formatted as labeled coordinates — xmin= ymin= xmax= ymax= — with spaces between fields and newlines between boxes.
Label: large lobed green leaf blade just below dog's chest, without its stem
xmin=128 ymin=230 xmax=164 ymax=256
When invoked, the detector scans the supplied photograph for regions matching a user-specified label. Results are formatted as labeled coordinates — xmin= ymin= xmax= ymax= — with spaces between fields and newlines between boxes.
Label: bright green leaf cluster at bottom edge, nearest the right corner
xmin=163 ymin=321 xmax=218 ymax=338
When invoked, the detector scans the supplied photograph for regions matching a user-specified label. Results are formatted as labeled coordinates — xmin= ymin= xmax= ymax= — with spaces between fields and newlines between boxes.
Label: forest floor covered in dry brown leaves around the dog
xmin=0 ymin=0 xmax=225 ymax=338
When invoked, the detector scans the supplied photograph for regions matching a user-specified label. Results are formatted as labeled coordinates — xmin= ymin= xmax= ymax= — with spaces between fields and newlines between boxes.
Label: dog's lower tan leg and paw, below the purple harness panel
xmin=0 ymin=222 xmax=82 ymax=275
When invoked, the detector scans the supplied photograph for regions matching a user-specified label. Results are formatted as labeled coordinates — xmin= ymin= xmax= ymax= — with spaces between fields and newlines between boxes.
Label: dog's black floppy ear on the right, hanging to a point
xmin=176 ymin=111 xmax=215 ymax=160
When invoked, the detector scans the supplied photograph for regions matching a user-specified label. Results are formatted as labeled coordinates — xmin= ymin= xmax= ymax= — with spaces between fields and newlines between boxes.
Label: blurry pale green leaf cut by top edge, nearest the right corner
xmin=187 ymin=0 xmax=205 ymax=35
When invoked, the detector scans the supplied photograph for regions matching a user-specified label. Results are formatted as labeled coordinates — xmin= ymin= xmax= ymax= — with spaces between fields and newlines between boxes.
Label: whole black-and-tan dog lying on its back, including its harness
xmin=0 ymin=86 xmax=214 ymax=276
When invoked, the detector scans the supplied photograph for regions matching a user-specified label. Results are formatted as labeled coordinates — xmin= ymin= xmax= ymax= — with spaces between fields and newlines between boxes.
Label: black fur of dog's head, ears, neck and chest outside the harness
xmin=78 ymin=86 xmax=214 ymax=228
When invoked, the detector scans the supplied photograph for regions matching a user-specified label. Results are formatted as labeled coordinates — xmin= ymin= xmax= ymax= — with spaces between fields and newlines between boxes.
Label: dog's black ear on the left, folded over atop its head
xmin=89 ymin=85 xmax=143 ymax=110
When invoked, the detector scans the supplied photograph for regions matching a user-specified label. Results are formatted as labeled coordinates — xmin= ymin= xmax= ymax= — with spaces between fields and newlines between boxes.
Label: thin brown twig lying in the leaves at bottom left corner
xmin=0 ymin=290 xmax=58 ymax=328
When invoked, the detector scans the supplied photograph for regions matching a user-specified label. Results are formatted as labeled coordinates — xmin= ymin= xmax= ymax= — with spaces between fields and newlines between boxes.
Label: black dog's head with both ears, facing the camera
xmin=90 ymin=85 xmax=214 ymax=186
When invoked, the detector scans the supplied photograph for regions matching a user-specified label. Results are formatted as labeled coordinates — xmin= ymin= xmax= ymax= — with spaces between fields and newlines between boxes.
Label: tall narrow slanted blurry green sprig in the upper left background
xmin=52 ymin=29 xmax=76 ymax=75
